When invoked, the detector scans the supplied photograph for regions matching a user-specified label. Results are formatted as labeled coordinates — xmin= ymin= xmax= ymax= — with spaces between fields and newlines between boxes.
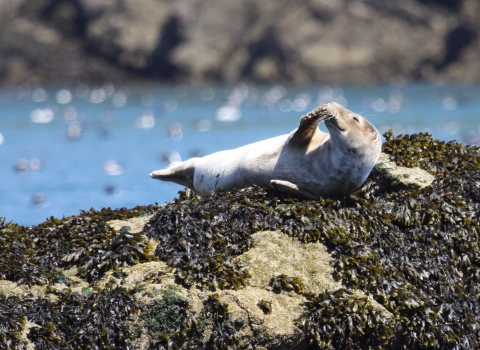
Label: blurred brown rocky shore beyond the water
xmin=0 ymin=0 xmax=480 ymax=86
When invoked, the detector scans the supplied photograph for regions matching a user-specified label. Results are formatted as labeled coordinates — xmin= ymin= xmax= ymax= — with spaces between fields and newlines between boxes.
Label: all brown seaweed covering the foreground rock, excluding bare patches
xmin=0 ymin=132 xmax=480 ymax=349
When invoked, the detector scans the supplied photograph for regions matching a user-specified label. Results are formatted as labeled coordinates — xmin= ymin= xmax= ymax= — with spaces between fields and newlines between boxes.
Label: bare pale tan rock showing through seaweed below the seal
xmin=0 ymin=216 xmax=393 ymax=349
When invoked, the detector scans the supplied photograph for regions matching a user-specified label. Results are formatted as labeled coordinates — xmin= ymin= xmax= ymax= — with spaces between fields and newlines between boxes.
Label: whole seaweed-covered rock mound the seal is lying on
xmin=0 ymin=133 xmax=480 ymax=349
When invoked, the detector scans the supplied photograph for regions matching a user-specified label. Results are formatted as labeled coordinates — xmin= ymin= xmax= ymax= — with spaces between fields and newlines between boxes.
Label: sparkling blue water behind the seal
xmin=0 ymin=84 xmax=480 ymax=225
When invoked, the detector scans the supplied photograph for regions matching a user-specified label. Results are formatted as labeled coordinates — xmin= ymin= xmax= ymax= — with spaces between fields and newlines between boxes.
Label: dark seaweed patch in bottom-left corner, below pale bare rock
xmin=0 ymin=288 xmax=137 ymax=349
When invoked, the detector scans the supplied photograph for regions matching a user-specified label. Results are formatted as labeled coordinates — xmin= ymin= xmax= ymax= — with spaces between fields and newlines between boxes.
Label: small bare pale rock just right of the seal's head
xmin=375 ymin=152 xmax=435 ymax=188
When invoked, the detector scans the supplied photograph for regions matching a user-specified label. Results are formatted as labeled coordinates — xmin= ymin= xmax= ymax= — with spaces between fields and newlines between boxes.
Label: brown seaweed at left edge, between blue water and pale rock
xmin=0 ymin=205 xmax=158 ymax=285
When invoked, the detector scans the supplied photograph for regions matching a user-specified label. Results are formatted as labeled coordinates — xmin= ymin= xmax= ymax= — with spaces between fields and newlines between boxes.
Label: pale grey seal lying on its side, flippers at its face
xmin=150 ymin=102 xmax=382 ymax=199
